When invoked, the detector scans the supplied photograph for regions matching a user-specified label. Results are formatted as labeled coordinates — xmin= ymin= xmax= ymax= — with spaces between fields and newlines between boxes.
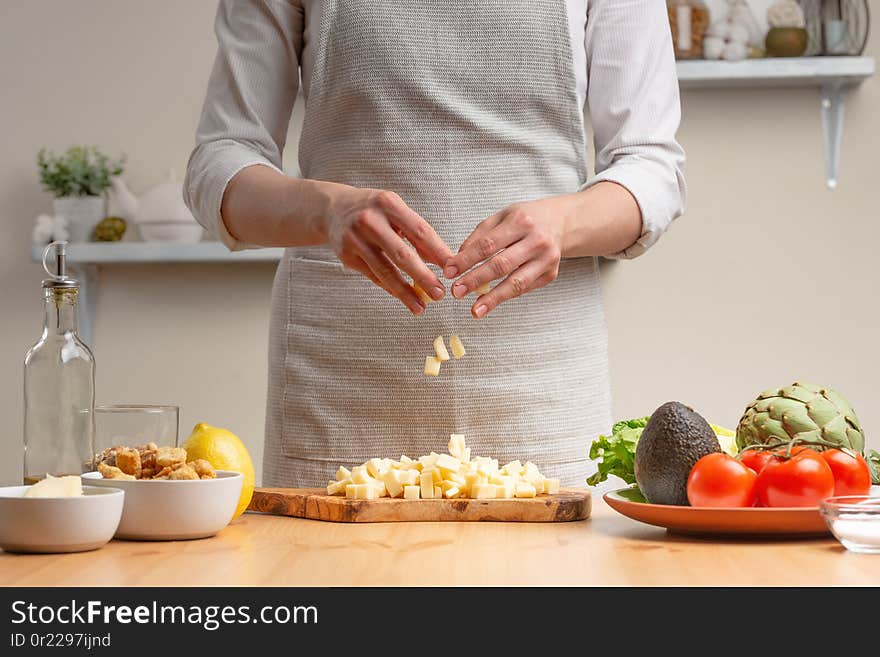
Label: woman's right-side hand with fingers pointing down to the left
xmin=443 ymin=197 xmax=569 ymax=317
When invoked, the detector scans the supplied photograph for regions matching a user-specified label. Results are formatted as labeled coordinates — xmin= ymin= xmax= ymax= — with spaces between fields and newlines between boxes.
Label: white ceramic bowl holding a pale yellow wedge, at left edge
xmin=0 ymin=486 xmax=124 ymax=552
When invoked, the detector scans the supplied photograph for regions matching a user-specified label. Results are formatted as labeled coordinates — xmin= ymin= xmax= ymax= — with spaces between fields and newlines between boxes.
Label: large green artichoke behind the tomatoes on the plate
xmin=736 ymin=383 xmax=865 ymax=454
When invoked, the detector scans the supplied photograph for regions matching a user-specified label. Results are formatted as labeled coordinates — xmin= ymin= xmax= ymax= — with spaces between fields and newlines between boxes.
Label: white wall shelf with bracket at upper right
xmin=677 ymin=57 xmax=875 ymax=189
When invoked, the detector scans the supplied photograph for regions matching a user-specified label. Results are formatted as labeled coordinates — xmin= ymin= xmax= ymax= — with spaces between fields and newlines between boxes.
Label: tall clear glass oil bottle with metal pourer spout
xmin=24 ymin=242 xmax=95 ymax=484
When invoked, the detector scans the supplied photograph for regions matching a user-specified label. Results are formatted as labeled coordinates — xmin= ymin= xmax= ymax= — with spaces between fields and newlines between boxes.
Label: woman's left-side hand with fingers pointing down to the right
xmin=326 ymin=186 xmax=452 ymax=315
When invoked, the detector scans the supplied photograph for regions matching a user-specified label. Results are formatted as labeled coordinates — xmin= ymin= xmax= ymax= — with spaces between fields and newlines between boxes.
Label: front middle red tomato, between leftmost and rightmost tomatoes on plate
xmin=756 ymin=449 xmax=834 ymax=507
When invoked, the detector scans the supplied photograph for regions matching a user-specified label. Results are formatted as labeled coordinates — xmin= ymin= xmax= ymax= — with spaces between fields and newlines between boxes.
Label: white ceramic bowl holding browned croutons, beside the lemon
xmin=82 ymin=470 xmax=242 ymax=541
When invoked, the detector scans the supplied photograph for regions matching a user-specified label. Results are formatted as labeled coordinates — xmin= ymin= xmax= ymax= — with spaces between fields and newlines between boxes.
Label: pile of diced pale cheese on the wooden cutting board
xmin=327 ymin=434 xmax=559 ymax=500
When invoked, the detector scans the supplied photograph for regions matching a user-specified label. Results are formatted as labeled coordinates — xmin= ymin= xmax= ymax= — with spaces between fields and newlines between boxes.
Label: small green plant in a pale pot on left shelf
xmin=37 ymin=146 xmax=124 ymax=242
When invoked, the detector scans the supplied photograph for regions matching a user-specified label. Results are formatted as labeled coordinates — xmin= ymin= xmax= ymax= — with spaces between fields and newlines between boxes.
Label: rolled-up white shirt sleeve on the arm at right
xmin=583 ymin=0 xmax=686 ymax=258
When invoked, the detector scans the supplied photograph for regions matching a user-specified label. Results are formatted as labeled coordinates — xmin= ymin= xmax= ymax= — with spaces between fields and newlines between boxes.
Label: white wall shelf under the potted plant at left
xmin=31 ymin=242 xmax=284 ymax=345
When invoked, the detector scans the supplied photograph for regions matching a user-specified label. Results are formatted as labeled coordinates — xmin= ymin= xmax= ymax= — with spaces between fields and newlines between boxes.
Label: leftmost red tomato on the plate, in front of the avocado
xmin=687 ymin=453 xmax=758 ymax=507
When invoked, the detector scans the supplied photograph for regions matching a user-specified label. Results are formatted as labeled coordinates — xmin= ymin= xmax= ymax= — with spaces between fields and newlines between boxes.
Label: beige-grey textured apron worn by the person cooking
xmin=263 ymin=0 xmax=610 ymax=486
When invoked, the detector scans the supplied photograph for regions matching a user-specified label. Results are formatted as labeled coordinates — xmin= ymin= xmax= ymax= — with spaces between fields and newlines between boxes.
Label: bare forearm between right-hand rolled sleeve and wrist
xmin=557 ymin=181 xmax=642 ymax=258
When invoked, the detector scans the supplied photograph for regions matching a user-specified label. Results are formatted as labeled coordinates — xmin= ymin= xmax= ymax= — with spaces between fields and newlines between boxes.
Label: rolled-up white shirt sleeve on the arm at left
xmin=183 ymin=0 xmax=303 ymax=251
